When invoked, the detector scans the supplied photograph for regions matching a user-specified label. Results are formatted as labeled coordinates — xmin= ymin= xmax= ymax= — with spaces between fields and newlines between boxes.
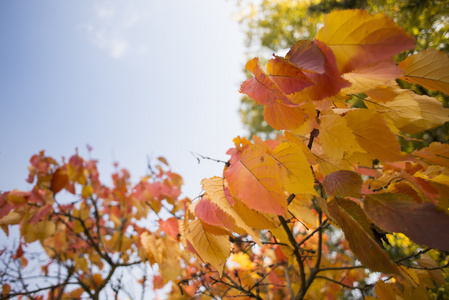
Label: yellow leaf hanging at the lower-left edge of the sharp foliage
xmin=186 ymin=220 xmax=231 ymax=277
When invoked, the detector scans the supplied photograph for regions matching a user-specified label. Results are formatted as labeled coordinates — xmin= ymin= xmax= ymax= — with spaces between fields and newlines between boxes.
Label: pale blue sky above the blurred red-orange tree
xmin=0 ymin=0 xmax=246 ymax=198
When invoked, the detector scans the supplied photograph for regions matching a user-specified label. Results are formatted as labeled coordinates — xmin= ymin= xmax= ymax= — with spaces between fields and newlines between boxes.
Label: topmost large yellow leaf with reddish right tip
xmin=316 ymin=9 xmax=415 ymax=73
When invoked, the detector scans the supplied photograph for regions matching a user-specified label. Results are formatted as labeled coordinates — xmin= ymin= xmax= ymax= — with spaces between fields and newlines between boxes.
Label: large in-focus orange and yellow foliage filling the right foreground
xmin=182 ymin=10 xmax=449 ymax=299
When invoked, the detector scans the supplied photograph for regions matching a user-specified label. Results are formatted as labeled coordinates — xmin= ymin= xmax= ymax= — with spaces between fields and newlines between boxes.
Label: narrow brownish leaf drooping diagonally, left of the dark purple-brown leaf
xmin=328 ymin=198 xmax=400 ymax=274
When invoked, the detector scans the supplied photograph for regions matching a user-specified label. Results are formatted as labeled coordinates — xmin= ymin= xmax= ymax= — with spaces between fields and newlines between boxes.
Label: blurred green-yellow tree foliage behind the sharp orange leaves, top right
xmin=239 ymin=0 xmax=449 ymax=143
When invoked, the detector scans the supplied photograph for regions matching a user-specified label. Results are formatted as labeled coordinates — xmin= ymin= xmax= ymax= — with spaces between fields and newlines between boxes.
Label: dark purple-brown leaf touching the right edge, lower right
xmin=365 ymin=194 xmax=449 ymax=251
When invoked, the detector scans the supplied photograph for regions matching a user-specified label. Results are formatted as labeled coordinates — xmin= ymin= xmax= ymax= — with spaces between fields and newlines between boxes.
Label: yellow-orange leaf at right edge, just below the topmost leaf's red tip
xmin=399 ymin=49 xmax=449 ymax=95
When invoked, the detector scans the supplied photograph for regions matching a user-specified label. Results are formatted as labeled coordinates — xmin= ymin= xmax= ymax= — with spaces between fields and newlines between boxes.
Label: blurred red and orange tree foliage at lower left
xmin=0 ymin=151 xmax=195 ymax=299
